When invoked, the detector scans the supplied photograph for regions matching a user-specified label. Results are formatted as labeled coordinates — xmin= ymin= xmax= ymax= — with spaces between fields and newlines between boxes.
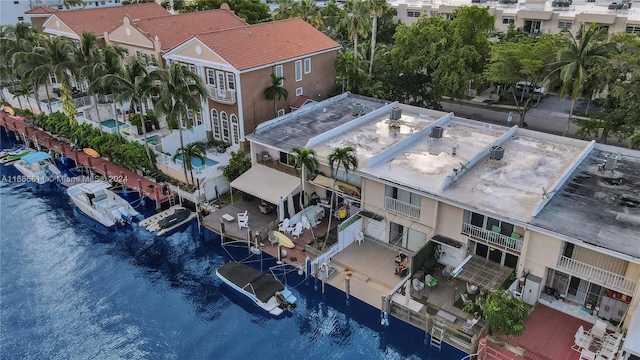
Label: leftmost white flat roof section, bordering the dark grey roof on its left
xmin=312 ymin=105 xmax=447 ymax=168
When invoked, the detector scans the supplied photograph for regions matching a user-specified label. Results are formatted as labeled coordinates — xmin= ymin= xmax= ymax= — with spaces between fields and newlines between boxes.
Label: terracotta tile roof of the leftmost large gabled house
xmin=48 ymin=2 xmax=170 ymax=37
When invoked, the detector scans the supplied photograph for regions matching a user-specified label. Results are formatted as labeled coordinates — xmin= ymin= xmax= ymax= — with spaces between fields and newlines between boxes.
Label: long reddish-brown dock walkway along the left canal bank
xmin=0 ymin=113 xmax=176 ymax=208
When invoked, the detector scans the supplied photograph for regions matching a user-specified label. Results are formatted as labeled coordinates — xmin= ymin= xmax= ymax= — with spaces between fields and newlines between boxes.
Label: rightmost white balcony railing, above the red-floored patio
xmin=557 ymin=256 xmax=636 ymax=295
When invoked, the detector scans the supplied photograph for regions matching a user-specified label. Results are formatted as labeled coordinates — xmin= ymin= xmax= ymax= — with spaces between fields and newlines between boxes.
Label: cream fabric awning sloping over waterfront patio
xmin=231 ymin=164 xmax=300 ymax=205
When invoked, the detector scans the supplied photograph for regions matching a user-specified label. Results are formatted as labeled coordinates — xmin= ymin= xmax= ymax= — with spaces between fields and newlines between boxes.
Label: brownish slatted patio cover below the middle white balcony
xmin=456 ymin=255 xmax=513 ymax=291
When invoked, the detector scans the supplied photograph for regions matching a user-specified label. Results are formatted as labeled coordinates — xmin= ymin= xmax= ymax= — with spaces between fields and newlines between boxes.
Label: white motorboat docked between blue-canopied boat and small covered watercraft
xmin=67 ymin=181 xmax=140 ymax=228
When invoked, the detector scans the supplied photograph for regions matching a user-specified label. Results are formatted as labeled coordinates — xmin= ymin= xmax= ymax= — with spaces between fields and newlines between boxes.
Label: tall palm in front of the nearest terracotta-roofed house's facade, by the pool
xmin=153 ymin=62 xmax=208 ymax=183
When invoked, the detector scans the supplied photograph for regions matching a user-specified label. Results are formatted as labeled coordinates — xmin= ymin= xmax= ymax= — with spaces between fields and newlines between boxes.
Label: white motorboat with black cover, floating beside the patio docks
xmin=216 ymin=262 xmax=297 ymax=316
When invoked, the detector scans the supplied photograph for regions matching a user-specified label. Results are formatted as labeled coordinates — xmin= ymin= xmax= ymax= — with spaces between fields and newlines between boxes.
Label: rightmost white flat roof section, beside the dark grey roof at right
xmin=443 ymin=129 xmax=589 ymax=221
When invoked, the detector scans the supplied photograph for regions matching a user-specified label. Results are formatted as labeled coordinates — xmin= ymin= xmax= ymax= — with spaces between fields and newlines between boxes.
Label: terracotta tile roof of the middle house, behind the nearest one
xmin=134 ymin=9 xmax=249 ymax=50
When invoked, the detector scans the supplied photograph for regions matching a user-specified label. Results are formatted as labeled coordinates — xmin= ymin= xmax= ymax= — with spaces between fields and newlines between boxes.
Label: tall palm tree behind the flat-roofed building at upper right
xmin=549 ymin=24 xmax=616 ymax=136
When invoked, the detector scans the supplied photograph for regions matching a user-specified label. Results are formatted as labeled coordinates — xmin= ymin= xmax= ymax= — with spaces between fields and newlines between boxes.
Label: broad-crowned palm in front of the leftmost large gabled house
xmin=14 ymin=36 xmax=74 ymax=112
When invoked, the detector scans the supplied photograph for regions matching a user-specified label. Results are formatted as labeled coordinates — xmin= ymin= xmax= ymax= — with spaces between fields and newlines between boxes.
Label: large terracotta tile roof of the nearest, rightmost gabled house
xmin=196 ymin=18 xmax=340 ymax=70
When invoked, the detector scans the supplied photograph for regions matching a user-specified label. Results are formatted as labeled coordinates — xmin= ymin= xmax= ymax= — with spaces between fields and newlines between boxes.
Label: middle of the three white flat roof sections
xmin=362 ymin=117 xmax=509 ymax=194
